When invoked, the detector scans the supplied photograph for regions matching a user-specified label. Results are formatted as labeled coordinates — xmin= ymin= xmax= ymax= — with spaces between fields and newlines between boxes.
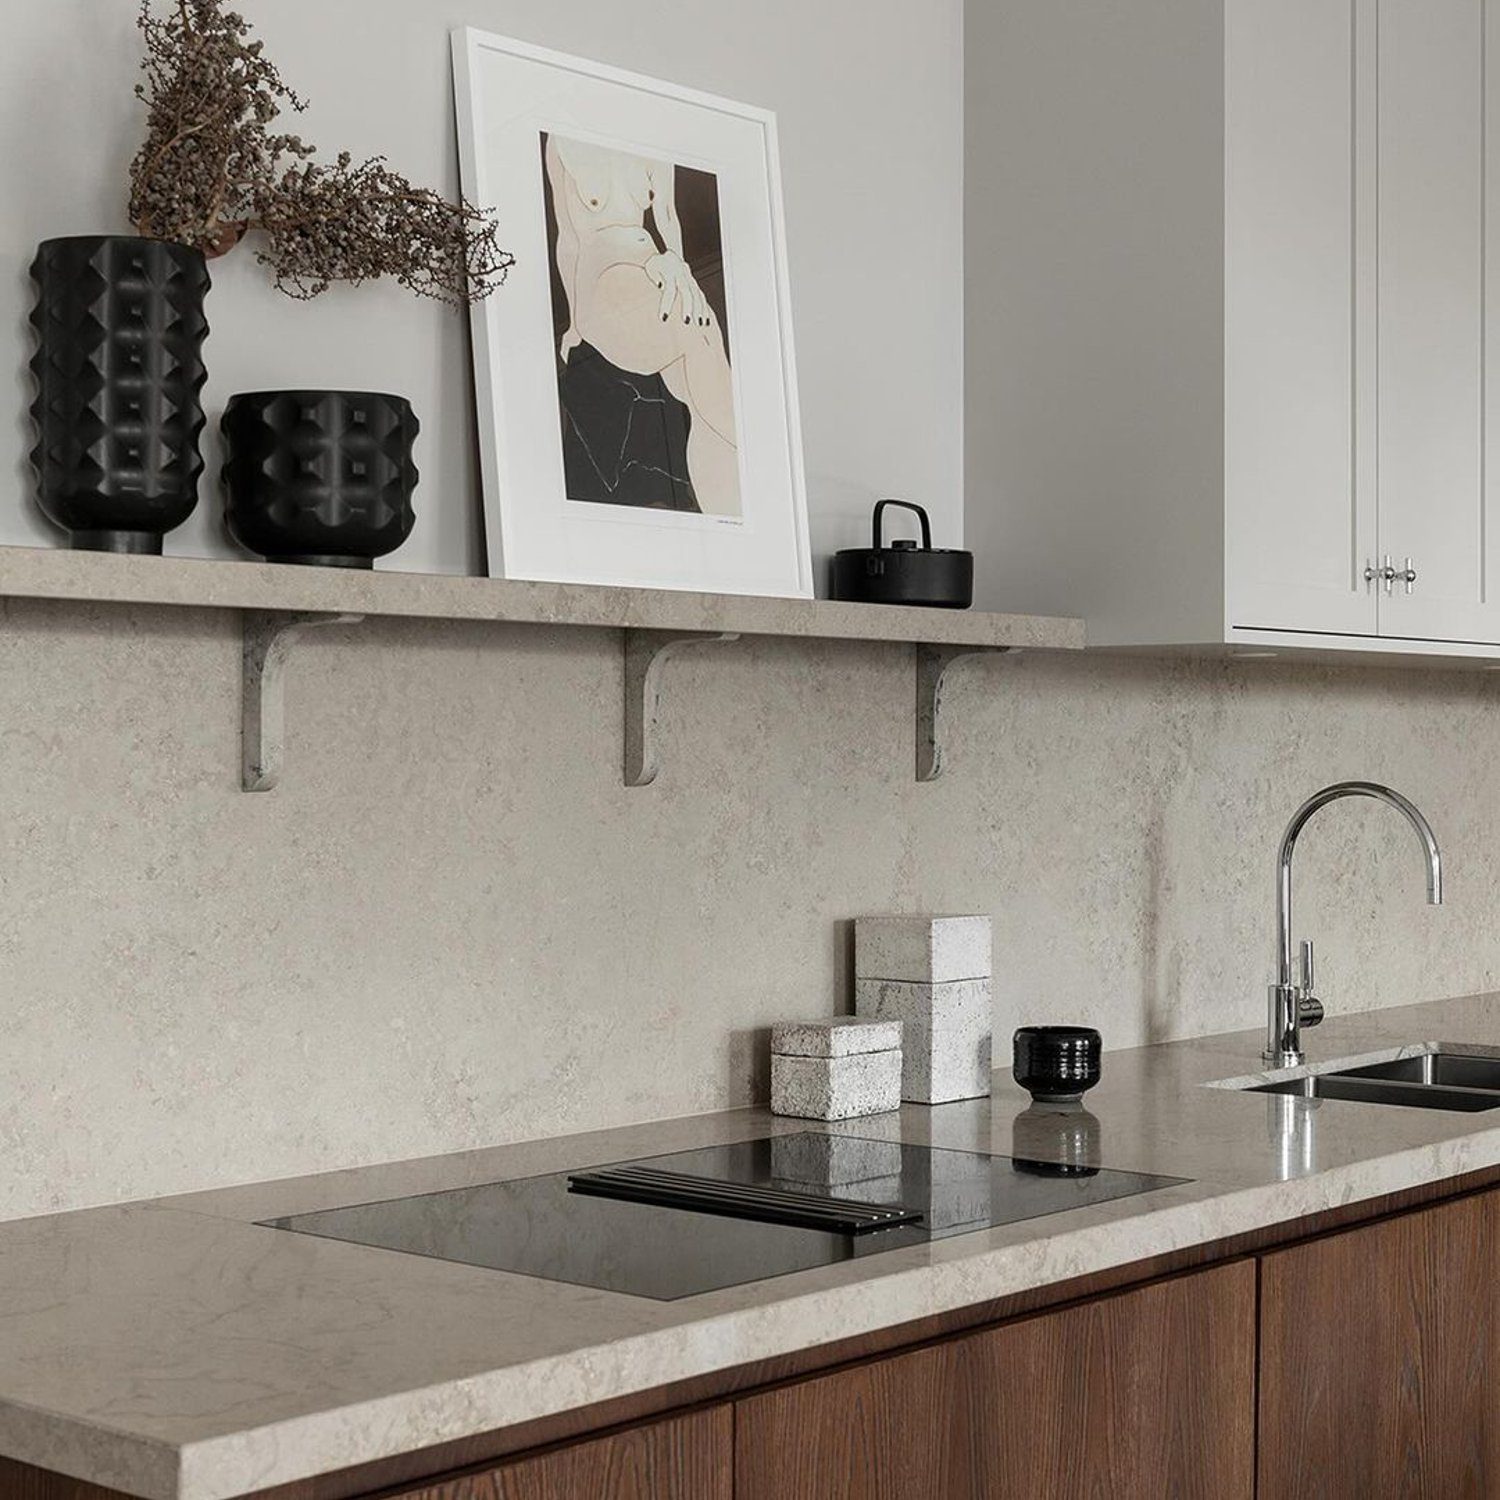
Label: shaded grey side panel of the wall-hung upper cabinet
xmin=963 ymin=0 xmax=1230 ymax=627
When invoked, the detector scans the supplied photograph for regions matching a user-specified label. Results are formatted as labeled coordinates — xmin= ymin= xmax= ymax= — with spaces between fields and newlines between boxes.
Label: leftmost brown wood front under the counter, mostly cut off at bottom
xmin=396 ymin=1406 xmax=734 ymax=1500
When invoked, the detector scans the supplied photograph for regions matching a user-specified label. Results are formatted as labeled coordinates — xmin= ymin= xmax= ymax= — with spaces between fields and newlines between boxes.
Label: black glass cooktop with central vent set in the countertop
xmin=267 ymin=1131 xmax=1187 ymax=1301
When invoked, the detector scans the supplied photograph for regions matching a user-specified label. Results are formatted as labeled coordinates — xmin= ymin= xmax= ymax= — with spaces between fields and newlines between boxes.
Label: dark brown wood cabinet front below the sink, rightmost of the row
xmin=1260 ymin=1193 xmax=1500 ymax=1500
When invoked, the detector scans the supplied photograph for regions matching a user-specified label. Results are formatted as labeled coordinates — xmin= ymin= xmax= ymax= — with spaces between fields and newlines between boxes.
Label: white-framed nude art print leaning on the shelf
xmin=453 ymin=30 xmax=813 ymax=597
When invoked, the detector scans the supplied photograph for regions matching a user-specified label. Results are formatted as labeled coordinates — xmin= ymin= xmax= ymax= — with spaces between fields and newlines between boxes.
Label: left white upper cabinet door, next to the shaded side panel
xmin=1224 ymin=0 xmax=1374 ymax=635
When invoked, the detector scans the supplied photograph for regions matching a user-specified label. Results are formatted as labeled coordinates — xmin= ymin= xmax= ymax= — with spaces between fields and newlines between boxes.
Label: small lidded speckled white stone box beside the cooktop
xmin=771 ymin=1016 xmax=902 ymax=1121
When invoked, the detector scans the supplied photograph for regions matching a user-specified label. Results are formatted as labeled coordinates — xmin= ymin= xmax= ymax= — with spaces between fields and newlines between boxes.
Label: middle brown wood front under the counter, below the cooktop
xmin=735 ymin=1260 xmax=1256 ymax=1500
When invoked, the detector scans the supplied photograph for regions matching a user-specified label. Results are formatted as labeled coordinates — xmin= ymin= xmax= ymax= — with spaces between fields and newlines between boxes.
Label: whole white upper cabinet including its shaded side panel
xmin=966 ymin=0 xmax=1500 ymax=656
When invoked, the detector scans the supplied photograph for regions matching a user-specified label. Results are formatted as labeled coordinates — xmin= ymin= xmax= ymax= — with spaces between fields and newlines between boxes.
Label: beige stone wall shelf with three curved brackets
xmin=0 ymin=548 xmax=1085 ymax=792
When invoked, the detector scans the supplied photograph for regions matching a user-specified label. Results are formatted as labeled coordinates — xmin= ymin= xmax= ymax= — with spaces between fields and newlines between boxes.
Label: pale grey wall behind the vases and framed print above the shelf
xmin=0 ymin=0 xmax=963 ymax=579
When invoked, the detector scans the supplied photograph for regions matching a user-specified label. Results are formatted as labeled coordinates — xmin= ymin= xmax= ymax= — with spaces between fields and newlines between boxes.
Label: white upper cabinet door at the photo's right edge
xmin=1377 ymin=0 xmax=1500 ymax=642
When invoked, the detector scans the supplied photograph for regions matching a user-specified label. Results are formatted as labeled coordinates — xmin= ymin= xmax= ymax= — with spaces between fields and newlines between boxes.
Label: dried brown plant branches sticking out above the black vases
xmin=129 ymin=0 xmax=515 ymax=305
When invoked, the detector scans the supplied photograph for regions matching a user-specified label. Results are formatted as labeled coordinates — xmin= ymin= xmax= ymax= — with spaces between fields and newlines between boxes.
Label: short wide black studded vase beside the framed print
xmin=221 ymin=390 xmax=417 ymax=567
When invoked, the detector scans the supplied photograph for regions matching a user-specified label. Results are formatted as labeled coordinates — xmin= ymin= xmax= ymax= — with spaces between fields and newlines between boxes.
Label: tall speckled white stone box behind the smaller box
xmin=854 ymin=917 xmax=995 ymax=1104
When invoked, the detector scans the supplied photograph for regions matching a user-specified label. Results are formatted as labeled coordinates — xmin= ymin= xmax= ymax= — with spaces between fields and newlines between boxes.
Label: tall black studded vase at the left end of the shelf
xmin=32 ymin=234 xmax=209 ymax=552
